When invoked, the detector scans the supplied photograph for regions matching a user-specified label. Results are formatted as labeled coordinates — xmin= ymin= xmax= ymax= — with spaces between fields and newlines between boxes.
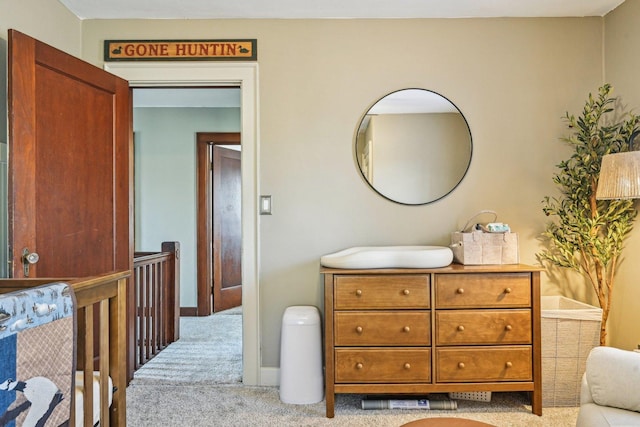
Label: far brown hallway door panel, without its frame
xmin=212 ymin=145 xmax=242 ymax=312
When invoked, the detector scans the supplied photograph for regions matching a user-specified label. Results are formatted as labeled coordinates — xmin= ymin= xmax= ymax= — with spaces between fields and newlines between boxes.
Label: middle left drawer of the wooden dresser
xmin=334 ymin=311 xmax=431 ymax=346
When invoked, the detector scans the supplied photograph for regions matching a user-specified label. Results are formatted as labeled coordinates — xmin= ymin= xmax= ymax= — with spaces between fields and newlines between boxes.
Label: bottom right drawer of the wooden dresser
xmin=436 ymin=346 xmax=533 ymax=382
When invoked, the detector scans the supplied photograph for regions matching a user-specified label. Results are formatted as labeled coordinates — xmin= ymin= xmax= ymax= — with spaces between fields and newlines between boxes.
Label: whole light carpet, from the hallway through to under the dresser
xmin=127 ymin=310 xmax=578 ymax=427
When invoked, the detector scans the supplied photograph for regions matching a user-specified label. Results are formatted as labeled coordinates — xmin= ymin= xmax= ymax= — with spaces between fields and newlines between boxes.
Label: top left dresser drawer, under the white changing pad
xmin=334 ymin=274 xmax=430 ymax=310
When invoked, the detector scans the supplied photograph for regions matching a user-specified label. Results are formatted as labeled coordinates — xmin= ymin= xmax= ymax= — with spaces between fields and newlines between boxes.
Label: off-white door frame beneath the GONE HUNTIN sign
xmin=104 ymin=62 xmax=262 ymax=385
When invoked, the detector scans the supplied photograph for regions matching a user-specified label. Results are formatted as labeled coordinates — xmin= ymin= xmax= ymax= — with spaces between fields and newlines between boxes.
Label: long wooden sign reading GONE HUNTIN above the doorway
xmin=104 ymin=39 xmax=258 ymax=61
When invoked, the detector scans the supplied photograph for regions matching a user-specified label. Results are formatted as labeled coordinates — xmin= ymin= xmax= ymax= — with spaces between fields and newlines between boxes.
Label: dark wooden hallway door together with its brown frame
xmin=196 ymin=132 xmax=242 ymax=316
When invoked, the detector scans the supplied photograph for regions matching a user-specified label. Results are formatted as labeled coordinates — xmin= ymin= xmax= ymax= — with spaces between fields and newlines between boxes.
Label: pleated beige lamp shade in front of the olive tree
xmin=596 ymin=151 xmax=640 ymax=200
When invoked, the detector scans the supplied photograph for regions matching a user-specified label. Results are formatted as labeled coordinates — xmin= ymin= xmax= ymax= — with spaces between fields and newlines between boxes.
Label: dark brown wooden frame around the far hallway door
xmin=196 ymin=132 xmax=242 ymax=316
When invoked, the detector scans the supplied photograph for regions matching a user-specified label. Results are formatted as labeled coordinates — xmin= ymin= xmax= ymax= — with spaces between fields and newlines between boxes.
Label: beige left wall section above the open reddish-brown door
xmin=0 ymin=0 xmax=82 ymax=57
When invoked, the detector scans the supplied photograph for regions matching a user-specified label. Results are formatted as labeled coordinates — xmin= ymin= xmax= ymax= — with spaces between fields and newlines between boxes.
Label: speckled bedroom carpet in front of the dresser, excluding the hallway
xmin=127 ymin=383 xmax=578 ymax=427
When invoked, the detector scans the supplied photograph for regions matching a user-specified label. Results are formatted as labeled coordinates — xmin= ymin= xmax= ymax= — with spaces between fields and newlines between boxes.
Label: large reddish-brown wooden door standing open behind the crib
xmin=8 ymin=30 xmax=133 ymax=277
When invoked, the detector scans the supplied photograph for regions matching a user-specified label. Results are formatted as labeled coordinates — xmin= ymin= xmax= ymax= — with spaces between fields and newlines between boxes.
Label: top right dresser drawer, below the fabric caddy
xmin=435 ymin=273 xmax=531 ymax=308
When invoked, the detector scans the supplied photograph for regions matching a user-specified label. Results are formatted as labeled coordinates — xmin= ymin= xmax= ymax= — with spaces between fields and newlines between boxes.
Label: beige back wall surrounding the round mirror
xmin=83 ymin=18 xmax=603 ymax=367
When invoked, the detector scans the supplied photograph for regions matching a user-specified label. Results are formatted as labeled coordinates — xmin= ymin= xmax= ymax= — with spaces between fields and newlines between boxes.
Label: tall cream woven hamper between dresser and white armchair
xmin=541 ymin=296 xmax=602 ymax=407
